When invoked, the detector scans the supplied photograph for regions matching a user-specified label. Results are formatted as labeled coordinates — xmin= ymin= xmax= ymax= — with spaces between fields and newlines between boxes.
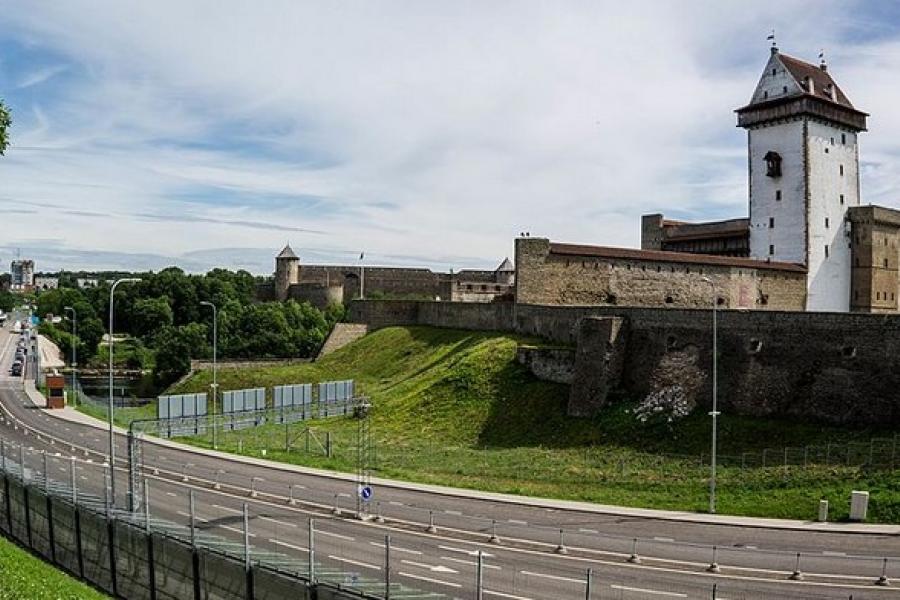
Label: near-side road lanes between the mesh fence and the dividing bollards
xmin=4 ymin=396 xmax=890 ymax=598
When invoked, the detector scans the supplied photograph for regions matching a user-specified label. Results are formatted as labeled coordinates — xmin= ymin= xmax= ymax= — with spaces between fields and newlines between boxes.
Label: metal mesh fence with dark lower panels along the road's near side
xmin=0 ymin=440 xmax=454 ymax=600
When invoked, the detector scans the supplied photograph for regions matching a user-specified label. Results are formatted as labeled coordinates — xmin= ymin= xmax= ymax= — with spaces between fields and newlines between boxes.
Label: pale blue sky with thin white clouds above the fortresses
xmin=0 ymin=0 xmax=900 ymax=274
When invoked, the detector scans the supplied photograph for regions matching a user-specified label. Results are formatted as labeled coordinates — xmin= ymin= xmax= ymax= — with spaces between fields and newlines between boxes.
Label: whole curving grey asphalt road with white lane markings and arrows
xmin=0 ymin=328 xmax=900 ymax=599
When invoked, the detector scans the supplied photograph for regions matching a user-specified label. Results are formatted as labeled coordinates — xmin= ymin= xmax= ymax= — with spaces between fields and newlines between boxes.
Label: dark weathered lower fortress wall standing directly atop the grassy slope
xmin=350 ymin=301 xmax=900 ymax=427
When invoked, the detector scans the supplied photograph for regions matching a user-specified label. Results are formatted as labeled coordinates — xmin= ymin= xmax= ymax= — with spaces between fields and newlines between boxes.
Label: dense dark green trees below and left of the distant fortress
xmin=36 ymin=267 xmax=344 ymax=386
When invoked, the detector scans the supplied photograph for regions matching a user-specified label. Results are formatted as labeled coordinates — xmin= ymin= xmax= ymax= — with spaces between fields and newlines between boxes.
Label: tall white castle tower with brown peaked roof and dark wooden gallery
xmin=736 ymin=46 xmax=868 ymax=312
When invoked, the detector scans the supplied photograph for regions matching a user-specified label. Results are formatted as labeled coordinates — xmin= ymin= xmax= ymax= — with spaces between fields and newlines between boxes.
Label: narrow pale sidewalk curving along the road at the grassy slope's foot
xmin=19 ymin=381 xmax=900 ymax=535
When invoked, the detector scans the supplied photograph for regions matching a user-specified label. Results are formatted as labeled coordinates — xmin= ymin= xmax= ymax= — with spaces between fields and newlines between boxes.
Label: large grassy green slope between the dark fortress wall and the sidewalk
xmin=100 ymin=327 xmax=900 ymax=522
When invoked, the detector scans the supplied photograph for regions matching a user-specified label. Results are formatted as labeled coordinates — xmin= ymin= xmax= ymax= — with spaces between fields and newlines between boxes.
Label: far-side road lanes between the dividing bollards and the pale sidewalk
xmin=0 ymin=326 xmax=894 ymax=596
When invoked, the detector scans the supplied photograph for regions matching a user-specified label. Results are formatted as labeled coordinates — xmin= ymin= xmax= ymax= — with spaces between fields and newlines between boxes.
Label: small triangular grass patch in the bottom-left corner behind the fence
xmin=0 ymin=537 xmax=109 ymax=600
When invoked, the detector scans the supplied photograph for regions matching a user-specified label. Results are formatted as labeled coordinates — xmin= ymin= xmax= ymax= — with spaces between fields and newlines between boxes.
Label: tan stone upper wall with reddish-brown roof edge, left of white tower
xmin=516 ymin=238 xmax=806 ymax=310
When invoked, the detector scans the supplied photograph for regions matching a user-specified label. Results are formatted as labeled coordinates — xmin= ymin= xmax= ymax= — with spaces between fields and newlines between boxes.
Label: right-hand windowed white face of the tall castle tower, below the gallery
xmin=807 ymin=120 xmax=859 ymax=312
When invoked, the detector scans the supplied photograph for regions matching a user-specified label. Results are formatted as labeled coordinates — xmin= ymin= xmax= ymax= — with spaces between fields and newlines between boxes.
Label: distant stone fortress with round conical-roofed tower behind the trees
xmin=257 ymin=245 xmax=515 ymax=308
